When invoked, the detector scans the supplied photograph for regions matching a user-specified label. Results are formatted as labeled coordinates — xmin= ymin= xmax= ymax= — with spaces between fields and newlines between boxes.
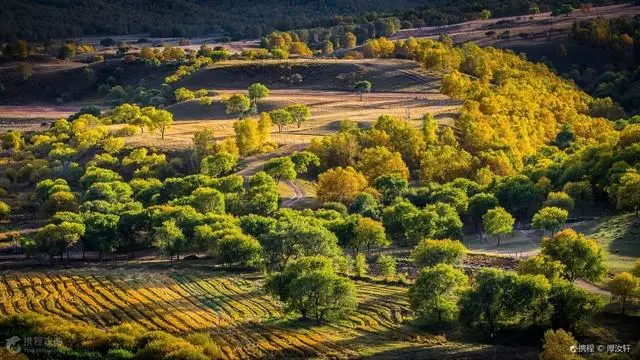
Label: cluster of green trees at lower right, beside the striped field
xmin=409 ymin=230 xmax=612 ymax=337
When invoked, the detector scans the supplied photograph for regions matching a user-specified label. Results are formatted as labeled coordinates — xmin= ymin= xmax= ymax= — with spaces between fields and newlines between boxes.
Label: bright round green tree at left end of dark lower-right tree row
xmin=409 ymin=263 xmax=467 ymax=324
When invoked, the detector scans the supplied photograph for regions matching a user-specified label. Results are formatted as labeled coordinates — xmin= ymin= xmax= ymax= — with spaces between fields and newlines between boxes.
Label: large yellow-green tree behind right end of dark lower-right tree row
xmin=540 ymin=229 xmax=607 ymax=281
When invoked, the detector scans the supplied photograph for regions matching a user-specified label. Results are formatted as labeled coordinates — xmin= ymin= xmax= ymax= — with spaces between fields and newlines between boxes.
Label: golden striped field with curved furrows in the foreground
xmin=0 ymin=269 xmax=524 ymax=359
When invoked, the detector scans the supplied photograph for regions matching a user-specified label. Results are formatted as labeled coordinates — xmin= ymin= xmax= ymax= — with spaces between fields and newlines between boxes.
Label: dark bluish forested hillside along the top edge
xmin=0 ymin=0 xmax=606 ymax=40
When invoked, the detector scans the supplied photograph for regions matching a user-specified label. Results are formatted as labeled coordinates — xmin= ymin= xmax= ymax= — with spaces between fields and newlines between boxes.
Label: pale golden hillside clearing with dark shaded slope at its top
xmin=120 ymin=60 xmax=461 ymax=149
